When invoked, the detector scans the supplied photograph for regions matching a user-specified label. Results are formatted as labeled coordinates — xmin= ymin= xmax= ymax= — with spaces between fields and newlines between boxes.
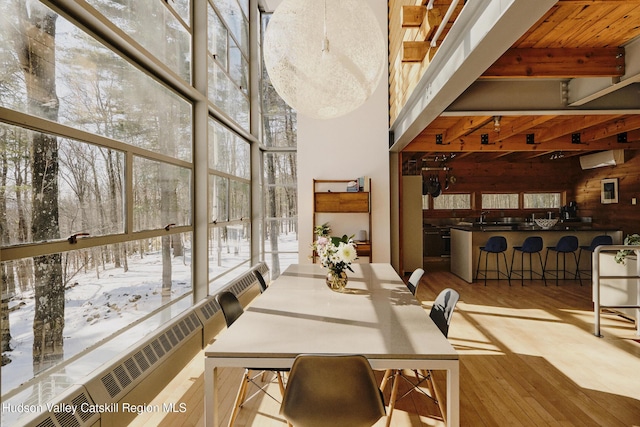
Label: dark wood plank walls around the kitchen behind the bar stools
xmin=423 ymin=150 xmax=640 ymax=236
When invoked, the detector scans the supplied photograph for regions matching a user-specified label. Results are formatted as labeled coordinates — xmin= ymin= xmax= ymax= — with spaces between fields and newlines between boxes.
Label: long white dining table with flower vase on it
xmin=204 ymin=263 xmax=460 ymax=427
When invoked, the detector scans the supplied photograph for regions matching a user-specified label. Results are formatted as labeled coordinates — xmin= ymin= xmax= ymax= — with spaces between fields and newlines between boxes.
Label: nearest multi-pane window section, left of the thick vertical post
xmin=0 ymin=0 xmax=195 ymax=414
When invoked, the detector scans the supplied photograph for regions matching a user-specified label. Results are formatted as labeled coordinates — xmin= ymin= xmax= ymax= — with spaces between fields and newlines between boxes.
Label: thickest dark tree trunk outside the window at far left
xmin=15 ymin=1 xmax=64 ymax=373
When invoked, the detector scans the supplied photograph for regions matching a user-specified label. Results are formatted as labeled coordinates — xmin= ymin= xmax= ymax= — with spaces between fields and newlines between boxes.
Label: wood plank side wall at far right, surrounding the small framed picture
xmin=574 ymin=150 xmax=640 ymax=236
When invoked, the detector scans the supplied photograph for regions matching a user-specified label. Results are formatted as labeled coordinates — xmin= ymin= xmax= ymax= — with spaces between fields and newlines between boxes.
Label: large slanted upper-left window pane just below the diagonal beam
xmin=0 ymin=5 xmax=192 ymax=161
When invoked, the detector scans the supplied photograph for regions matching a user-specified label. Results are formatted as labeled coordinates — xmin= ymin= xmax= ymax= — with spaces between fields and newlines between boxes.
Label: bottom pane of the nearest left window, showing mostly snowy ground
xmin=0 ymin=237 xmax=191 ymax=394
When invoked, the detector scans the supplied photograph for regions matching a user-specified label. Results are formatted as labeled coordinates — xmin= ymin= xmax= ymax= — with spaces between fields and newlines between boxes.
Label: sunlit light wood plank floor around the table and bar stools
xmin=131 ymin=261 xmax=640 ymax=427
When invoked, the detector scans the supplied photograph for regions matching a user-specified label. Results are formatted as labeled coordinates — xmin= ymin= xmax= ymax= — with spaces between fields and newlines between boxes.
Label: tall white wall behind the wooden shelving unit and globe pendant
xmin=298 ymin=0 xmax=391 ymax=263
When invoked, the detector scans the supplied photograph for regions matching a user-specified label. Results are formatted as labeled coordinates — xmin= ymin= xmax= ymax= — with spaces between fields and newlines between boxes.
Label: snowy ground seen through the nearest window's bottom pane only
xmin=2 ymin=252 xmax=191 ymax=394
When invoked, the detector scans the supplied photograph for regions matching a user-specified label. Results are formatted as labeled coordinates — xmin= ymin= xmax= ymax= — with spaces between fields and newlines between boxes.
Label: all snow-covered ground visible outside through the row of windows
xmin=0 ymin=233 xmax=304 ymax=426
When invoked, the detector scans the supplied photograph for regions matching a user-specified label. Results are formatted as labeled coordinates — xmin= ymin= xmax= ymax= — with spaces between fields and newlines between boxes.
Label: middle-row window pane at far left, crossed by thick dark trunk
xmin=0 ymin=123 xmax=124 ymax=246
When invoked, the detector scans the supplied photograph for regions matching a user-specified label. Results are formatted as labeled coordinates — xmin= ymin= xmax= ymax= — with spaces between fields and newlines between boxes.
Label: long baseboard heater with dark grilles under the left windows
xmin=13 ymin=263 xmax=269 ymax=427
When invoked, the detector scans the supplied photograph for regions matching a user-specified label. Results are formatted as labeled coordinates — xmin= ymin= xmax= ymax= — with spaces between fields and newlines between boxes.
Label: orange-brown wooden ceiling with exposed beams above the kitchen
xmin=402 ymin=0 xmax=640 ymax=168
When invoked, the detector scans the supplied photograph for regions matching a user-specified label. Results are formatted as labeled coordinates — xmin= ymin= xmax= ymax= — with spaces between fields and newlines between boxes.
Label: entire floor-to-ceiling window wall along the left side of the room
xmin=0 ymin=0 xmax=256 ymax=424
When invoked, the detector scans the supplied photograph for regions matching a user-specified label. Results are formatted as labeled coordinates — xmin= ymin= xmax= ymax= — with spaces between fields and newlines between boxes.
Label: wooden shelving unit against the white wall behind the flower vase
xmin=312 ymin=178 xmax=373 ymax=262
